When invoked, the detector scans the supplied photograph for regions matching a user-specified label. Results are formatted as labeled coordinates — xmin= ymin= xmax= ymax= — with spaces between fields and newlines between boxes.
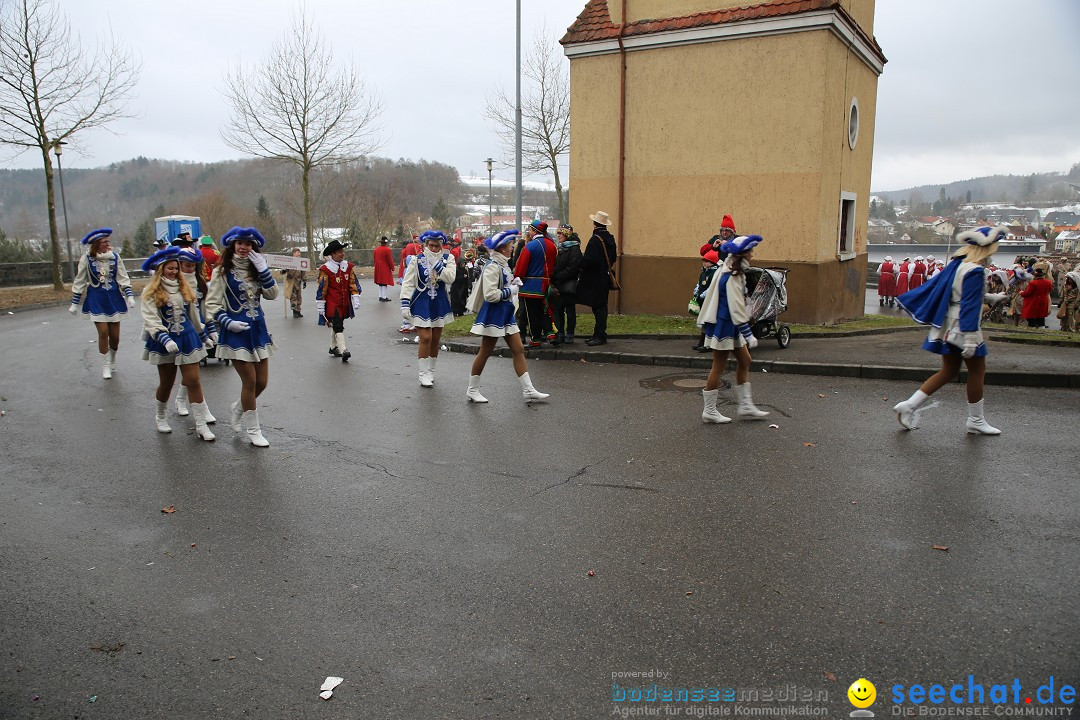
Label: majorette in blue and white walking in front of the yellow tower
xmin=698 ymin=235 xmax=769 ymax=423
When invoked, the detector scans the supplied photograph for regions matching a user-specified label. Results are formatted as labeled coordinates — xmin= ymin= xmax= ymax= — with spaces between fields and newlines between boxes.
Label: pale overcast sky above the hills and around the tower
xmin=9 ymin=0 xmax=1080 ymax=190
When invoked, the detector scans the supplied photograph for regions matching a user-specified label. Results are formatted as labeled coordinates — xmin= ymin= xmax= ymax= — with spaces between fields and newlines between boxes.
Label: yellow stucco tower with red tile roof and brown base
xmin=562 ymin=0 xmax=886 ymax=323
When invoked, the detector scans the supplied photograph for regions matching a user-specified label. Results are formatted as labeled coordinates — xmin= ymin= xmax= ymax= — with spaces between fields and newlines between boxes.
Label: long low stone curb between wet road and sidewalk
xmin=442 ymin=343 xmax=1080 ymax=389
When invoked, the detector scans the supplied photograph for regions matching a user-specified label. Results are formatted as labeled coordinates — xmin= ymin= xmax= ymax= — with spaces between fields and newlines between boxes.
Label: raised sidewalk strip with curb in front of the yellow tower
xmin=443 ymin=327 xmax=1080 ymax=389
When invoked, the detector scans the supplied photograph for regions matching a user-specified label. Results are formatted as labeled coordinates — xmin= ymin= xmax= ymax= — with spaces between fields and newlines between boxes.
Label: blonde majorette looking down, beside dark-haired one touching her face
xmin=141 ymin=247 xmax=214 ymax=440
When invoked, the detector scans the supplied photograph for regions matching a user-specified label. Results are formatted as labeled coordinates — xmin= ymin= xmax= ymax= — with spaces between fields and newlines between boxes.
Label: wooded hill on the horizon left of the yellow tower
xmin=0 ymin=158 xmax=468 ymax=256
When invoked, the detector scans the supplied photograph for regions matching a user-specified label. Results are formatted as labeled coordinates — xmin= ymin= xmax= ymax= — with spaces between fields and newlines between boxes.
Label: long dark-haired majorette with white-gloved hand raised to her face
xmin=206 ymin=228 xmax=278 ymax=448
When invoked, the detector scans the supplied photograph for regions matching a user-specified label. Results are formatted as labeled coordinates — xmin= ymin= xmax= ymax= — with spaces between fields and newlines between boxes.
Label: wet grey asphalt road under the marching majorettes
xmin=0 ymin=293 xmax=1080 ymax=719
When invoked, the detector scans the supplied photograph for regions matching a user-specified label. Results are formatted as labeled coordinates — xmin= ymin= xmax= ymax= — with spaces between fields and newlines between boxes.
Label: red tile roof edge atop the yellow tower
xmin=559 ymin=0 xmax=885 ymax=62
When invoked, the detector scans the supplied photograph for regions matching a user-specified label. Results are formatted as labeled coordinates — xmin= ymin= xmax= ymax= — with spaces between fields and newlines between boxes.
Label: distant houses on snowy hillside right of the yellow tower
xmin=867 ymin=205 xmax=1080 ymax=253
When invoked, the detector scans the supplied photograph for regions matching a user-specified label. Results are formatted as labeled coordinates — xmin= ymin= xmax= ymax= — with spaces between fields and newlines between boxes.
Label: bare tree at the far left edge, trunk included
xmin=0 ymin=0 xmax=139 ymax=290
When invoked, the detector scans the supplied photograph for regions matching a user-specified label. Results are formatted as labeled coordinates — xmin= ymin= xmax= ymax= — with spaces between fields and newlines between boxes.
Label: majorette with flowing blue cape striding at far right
xmin=892 ymin=226 xmax=1008 ymax=435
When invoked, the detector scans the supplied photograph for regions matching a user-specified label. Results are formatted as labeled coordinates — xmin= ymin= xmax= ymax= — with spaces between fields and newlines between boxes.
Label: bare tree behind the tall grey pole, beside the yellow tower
xmin=484 ymin=26 xmax=570 ymax=222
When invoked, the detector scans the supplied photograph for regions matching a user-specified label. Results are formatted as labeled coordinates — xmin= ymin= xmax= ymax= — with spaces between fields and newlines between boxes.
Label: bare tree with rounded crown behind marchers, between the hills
xmin=221 ymin=8 xmax=382 ymax=262
